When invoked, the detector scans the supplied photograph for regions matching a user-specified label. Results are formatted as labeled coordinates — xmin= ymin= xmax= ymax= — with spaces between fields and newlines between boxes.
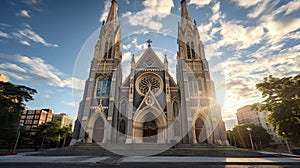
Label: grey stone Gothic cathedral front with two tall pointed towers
xmin=73 ymin=0 xmax=227 ymax=145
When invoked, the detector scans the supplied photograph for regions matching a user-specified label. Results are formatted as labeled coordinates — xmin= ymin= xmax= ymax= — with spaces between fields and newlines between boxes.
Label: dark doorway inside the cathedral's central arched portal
xmin=143 ymin=120 xmax=157 ymax=143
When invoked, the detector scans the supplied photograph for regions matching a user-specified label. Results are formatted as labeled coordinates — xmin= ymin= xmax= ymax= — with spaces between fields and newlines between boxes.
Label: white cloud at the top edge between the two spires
xmin=128 ymin=0 xmax=174 ymax=31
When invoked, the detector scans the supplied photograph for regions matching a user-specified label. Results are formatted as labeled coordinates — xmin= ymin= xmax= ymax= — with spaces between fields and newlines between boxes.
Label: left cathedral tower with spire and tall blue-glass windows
xmin=74 ymin=0 xmax=122 ymax=143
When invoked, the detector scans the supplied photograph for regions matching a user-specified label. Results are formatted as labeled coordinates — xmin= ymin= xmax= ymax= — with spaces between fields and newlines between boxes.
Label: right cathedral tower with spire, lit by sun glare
xmin=176 ymin=0 xmax=226 ymax=144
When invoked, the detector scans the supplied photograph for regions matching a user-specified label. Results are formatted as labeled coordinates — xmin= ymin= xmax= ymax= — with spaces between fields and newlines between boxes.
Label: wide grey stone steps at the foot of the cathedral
xmin=33 ymin=143 xmax=274 ymax=157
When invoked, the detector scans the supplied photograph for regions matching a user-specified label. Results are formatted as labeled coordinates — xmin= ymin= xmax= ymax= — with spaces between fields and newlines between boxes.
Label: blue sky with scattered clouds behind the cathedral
xmin=0 ymin=0 xmax=300 ymax=129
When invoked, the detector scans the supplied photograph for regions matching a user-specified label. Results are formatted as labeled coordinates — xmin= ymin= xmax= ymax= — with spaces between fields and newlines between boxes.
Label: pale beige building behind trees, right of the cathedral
xmin=236 ymin=105 xmax=282 ymax=143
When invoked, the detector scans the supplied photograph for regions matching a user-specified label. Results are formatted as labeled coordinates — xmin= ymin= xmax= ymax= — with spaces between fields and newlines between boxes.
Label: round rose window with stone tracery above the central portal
xmin=136 ymin=73 xmax=163 ymax=96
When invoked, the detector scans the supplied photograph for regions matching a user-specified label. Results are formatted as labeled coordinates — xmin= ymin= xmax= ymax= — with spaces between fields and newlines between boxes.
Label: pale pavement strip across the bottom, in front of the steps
xmin=0 ymin=155 xmax=300 ymax=165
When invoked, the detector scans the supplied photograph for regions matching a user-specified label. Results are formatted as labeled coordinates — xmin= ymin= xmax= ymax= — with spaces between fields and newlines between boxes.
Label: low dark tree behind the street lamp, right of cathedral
xmin=228 ymin=124 xmax=271 ymax=149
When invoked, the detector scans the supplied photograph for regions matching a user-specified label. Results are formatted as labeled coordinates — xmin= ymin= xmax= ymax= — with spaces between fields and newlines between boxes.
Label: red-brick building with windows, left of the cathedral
xmin=20 ymin=109 xmax=53 ymax=133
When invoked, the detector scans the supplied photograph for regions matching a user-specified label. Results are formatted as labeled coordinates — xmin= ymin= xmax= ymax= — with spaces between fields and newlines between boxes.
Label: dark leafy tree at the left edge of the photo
xmin=0 ymin=82 xmax=37 ymax=148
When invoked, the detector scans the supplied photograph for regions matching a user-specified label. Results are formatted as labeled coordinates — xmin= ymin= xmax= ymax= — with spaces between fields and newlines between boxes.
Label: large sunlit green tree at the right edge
xmin=256 ymin=74 xmax=300 ymax=143
